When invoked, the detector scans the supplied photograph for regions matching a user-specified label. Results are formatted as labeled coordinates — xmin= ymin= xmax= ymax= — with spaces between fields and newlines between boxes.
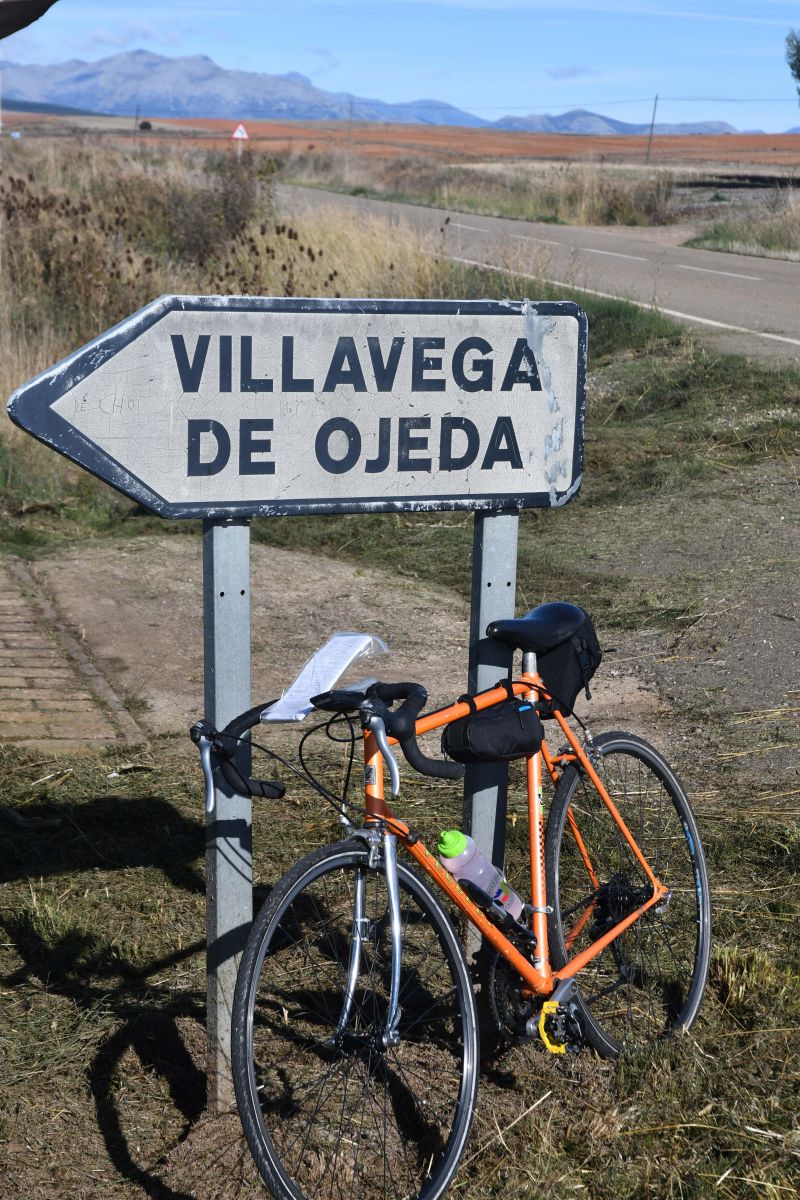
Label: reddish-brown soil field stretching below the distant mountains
xmin=6 ymin=113 xmax=800 ymax=169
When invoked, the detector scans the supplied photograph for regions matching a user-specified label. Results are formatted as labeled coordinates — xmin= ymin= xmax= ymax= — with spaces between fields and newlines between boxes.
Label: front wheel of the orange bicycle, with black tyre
xmin=233 ymin=840 xmax=477 ymax=1200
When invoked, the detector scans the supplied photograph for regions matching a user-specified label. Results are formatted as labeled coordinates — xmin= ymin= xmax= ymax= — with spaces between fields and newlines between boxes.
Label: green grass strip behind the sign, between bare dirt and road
xmin=9 ymin=252 xmax=800 ymax=604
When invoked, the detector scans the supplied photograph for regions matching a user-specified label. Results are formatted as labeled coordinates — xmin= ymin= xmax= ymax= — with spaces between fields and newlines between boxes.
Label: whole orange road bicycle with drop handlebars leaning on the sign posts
xmin=193 ymin=604 xmax=711 ymax=1200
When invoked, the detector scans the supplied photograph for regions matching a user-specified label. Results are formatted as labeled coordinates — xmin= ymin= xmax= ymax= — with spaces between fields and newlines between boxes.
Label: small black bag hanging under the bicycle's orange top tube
xmin=441 ymin=696 xmax=545 ymax=762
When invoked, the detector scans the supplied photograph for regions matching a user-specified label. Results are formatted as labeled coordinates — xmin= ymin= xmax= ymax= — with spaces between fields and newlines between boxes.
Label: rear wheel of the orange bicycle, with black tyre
xmin=545 ymin=732 xmax=711 ymax=1058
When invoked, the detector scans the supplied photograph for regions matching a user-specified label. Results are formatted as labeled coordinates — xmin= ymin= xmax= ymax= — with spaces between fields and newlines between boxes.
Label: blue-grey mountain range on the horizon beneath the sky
xmin=0 ymin=50 xmax=753 ymax=136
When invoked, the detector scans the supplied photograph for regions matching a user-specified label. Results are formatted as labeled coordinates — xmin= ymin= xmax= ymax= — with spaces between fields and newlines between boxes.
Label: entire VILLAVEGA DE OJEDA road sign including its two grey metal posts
xmin=8 ymin=296 xmax=587 ymax=1111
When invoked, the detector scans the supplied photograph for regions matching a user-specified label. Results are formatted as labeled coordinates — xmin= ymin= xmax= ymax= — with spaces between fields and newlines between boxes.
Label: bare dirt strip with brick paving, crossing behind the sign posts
xmin=0 ymin=448 xmax=800 ymax=779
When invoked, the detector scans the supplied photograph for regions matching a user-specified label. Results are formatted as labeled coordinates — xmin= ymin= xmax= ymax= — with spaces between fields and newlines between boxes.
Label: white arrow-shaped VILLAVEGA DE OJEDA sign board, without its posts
xmin=8 ymin=296 xmax=587 ymax=517
